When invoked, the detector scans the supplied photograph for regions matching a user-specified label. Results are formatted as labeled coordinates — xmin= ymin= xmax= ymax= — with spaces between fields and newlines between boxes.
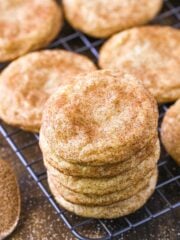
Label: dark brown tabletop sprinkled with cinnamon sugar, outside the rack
xmin=0 ymin=135 xmax=180 ymax=240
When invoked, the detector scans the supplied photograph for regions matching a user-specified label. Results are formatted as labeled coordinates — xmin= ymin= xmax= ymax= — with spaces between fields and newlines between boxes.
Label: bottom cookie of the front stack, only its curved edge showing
xmin=49 ymin=168 xmax=158 ymax=219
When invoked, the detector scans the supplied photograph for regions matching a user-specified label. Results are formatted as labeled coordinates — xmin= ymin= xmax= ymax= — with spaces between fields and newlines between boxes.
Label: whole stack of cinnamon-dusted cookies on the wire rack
xmin=40 ymin=70 xmax=160 ymax=218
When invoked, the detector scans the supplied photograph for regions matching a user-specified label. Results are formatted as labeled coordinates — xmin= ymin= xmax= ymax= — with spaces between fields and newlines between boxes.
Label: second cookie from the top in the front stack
xmin=41 ymin=135 xmax=159 ymax=178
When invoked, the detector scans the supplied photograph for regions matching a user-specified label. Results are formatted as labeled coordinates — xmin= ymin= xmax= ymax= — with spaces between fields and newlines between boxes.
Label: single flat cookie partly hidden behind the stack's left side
xmin=0 ymin=50 xmax=96 ymax=132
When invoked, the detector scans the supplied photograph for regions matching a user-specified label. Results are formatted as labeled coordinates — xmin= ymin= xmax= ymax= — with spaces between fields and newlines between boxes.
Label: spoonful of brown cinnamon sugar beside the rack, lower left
xmin=0 ymin=159 xmax=21 ymax=239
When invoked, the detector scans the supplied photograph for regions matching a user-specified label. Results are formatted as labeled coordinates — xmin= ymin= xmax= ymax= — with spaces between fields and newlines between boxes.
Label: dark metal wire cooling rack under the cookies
xmin=0 ymin=0 xmax=180 ymax=240
